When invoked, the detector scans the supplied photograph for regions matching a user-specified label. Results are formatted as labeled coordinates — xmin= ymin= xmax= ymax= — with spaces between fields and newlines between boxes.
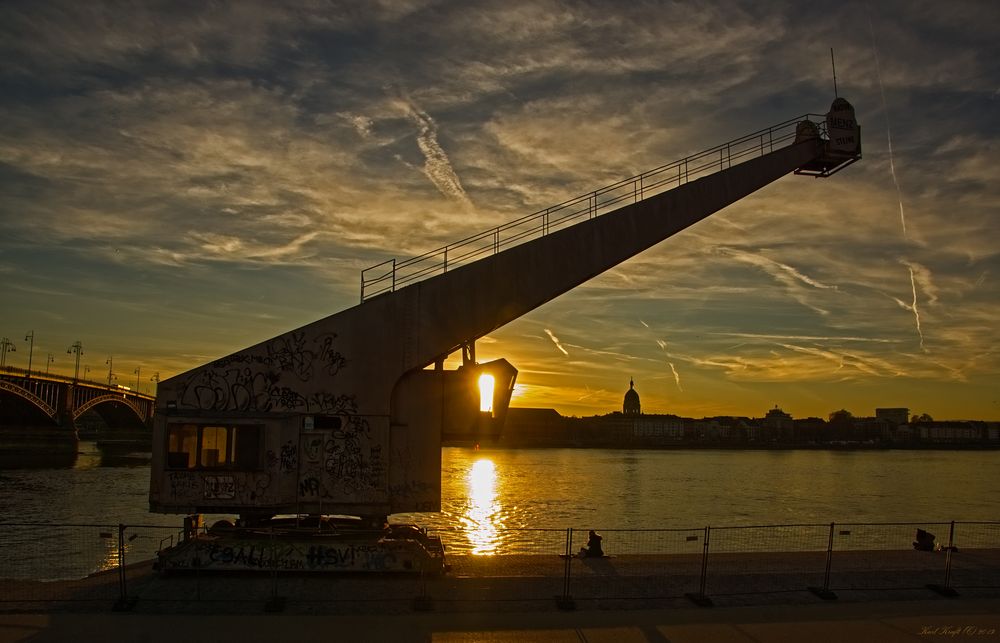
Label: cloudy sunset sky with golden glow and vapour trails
xmin=0 ymin=0 xmax=1000 ymax=420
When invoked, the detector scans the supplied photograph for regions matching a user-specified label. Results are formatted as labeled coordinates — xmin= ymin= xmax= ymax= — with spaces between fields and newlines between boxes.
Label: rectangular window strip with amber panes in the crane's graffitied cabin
xmin=167 ymin=424 xmax=261 ymax=470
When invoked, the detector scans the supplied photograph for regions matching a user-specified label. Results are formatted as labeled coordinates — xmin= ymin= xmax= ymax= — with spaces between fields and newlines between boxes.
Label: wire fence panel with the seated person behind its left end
xmin=569 ymin=528 xmax=705 ymax=601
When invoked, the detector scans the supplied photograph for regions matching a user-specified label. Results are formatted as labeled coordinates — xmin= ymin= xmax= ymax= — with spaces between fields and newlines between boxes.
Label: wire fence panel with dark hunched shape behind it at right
xmin=830 ymin=523 xmax=951 ymax=591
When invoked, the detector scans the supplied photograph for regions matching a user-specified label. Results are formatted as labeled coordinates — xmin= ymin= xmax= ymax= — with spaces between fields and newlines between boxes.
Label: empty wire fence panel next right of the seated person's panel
xmin=704 ymin=524 xmax=830 ymax=596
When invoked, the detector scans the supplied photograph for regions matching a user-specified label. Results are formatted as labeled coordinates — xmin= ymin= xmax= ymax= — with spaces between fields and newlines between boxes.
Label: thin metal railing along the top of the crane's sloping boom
xmin=361 ymin=114 xmax=826 ymax=303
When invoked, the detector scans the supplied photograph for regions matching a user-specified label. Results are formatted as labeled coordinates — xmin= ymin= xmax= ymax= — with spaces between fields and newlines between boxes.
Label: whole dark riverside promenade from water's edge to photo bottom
xmin=0 ymin=550 xmax=1000 ymax=643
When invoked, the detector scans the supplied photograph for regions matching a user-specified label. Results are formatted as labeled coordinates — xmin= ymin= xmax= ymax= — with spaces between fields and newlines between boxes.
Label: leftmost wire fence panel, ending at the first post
xmin=0 ymin=523 xmax=119 ymax=611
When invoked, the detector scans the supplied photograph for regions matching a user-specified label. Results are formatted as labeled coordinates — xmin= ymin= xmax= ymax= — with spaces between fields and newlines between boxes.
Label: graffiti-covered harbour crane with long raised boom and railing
xmin=149 ymin=98 xmax=861 ymax=572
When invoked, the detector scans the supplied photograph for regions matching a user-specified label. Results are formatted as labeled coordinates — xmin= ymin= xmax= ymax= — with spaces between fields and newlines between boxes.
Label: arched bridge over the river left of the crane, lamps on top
xmin=0 ymin=367 xmax=156 ymax=447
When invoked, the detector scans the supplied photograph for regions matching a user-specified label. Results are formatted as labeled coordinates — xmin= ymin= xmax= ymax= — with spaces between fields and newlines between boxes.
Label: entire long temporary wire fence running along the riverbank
xmin=0 ymin=521 xmax=1000 ymax=613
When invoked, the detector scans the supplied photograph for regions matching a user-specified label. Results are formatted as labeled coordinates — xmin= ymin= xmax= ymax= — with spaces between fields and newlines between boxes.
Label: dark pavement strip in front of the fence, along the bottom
xmin=0 ymin=597 xmax=1000 ymax=643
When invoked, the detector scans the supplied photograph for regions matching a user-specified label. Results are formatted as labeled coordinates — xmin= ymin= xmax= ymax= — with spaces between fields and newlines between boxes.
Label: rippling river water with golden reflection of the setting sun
xmin=0 ymin=442 xmax=1000 ymax=577
